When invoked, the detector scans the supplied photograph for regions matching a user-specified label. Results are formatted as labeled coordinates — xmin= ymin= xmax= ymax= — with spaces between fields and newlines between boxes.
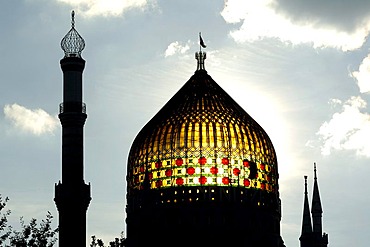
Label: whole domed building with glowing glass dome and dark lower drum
xmin=126 ymin=51 xmax=285 ymax=247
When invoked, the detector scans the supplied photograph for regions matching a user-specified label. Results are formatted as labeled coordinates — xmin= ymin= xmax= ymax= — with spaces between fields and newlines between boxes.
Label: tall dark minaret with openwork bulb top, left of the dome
xmin=54 ymin=11 xmax=91 ymax=247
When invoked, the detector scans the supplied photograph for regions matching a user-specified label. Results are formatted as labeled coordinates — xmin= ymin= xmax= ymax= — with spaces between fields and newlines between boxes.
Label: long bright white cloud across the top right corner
xmin=221 ymin=0 xmax=370 ymax=51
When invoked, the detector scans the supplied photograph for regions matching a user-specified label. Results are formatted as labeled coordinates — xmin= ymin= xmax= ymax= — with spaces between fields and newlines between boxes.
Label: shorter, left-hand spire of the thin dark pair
xmin=299 ymin=176 xmax=313 ymax=247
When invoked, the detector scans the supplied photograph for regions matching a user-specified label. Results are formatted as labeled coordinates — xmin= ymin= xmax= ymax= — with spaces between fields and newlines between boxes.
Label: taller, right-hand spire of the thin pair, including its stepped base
xmin=311 ymin=163 xmax=328 ymax=247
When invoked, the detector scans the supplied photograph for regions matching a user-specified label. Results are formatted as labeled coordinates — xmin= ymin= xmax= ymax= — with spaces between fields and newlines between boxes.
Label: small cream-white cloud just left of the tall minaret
xmin=4 ymin=104 xmax=58 ymax=135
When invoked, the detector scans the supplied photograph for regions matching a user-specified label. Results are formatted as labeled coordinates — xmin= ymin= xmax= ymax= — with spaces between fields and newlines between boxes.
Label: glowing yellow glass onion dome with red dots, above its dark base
xmin=127 ymin=53 xmax=278 ymax=194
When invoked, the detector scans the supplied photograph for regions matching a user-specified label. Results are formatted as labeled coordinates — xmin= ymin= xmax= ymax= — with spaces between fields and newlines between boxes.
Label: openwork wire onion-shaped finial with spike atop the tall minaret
xmin=60 ymin=11 xmax=85 ymax=57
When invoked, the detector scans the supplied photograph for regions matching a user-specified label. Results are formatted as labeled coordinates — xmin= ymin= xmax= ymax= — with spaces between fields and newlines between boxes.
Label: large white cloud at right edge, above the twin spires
xmin=316 ymin=96 xmax=370 ymax=157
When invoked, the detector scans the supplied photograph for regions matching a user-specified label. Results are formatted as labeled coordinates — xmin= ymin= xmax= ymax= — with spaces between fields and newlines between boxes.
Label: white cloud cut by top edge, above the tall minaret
xmin=57 ymin=0 xmax=154 ymax=16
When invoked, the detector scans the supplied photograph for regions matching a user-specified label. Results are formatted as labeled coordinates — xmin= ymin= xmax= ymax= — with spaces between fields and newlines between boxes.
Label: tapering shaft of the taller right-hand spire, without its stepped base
xmin=311 ymin=163 xmax=323 ymax=236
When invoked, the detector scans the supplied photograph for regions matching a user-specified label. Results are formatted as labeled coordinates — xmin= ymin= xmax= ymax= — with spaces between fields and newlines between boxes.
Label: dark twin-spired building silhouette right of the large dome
xmin=299 ymin=164 xmax=328 ymax=247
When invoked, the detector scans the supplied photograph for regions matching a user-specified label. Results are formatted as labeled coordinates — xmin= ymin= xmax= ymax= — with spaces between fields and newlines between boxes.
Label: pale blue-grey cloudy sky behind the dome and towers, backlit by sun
xmin=0 ymin=0 xmax=370 ymax=247
